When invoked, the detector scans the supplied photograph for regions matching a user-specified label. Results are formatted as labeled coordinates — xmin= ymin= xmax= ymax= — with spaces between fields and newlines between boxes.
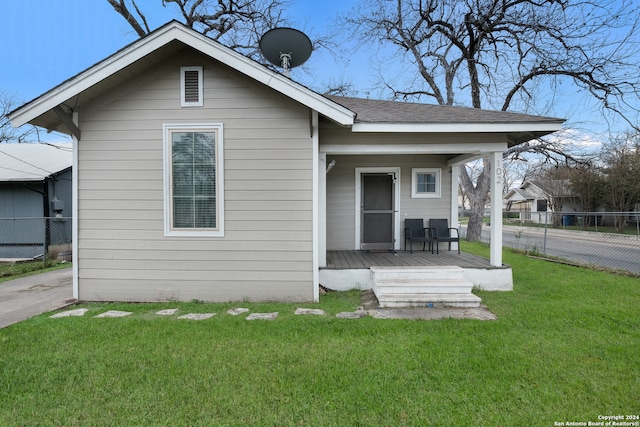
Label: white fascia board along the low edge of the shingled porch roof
xmin=352 ymin=122 xmax=562 ymax=133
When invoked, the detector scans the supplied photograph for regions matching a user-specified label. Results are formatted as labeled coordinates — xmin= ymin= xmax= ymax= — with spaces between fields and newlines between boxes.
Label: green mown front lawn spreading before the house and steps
xmin=0 ymin=242 xmax=640 ymax=426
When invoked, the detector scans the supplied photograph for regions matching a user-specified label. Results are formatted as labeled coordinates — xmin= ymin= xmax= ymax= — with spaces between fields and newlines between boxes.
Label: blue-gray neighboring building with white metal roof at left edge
xmin=0 ymin=143 xmax=73 ymax=259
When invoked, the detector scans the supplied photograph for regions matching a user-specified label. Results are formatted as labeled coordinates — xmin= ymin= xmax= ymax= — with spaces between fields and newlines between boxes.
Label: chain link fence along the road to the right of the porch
xmin=492 ymin=211 xmax=640 ymax=274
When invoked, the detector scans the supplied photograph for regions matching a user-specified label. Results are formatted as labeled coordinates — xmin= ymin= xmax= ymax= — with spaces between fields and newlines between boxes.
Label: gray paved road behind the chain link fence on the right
xmin=464 ymin=226 xmax=640 ymax=273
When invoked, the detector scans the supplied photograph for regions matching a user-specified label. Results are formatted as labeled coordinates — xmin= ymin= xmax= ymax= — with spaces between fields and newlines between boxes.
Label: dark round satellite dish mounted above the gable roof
xmin=259 ymin=28 xmax=313 ymax=77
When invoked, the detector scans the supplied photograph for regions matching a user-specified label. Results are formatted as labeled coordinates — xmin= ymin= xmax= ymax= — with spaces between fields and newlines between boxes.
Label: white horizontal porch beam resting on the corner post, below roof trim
xmin=320 ymin=142 xmax=507 ymax=155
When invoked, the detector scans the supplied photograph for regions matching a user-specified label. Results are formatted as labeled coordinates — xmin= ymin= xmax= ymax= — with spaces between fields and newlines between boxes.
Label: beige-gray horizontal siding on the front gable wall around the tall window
xmin=78 ymin=51 xmax=313 ymax=301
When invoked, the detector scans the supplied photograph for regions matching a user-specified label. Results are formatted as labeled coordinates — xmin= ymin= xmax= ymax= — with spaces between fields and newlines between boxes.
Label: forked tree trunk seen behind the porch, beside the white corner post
xmin=460 ymin=158 xmax=492 ymax=242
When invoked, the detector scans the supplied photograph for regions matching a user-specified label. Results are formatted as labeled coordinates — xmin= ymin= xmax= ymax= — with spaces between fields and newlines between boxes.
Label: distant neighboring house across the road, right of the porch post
xmin=504 ymin=180 xmax=581 ymax=225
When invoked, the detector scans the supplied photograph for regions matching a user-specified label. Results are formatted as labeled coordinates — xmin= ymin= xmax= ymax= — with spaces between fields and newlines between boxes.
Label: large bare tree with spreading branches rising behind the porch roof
xmin=344 ymin=0 xmax=640 ymax=241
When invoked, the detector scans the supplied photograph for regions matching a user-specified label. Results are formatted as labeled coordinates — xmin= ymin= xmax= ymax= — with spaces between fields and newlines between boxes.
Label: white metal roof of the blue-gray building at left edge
xmin=0 ymin=142 xmax=73 ymax=182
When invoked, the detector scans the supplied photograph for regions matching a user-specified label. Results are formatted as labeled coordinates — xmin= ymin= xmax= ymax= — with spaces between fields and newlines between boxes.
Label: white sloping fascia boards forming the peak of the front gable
xmin=9 ymin=23 xmax=355 ymax=127
